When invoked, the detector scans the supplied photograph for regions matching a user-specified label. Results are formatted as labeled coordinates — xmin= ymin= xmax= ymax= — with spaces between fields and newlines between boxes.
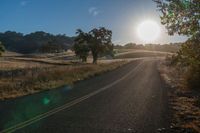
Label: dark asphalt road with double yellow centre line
xmin=0 ymin=59 xmax=169 ymax=133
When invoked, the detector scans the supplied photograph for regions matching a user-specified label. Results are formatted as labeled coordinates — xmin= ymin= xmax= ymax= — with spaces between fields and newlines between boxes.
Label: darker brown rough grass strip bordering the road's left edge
xmin=0 ymin=61 xmax=127 ymax=99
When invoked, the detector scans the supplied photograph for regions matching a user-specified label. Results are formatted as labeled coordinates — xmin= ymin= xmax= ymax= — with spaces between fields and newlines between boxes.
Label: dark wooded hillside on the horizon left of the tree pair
xmin=0 ymin=31 xmax=74 ymax=53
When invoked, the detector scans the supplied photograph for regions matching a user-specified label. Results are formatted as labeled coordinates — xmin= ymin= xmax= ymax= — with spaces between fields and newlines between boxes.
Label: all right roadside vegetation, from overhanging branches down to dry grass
xmin=154 ymin=0 xmax=200 ymax=133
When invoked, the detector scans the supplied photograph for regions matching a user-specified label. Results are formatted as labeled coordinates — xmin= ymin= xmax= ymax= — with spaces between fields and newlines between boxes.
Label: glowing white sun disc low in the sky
xmin=137 ymin=20 xmax=160 ymax=43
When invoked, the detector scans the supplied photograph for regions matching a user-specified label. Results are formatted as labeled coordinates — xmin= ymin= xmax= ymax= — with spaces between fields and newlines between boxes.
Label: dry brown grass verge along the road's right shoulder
xmin=159 ymin=62 xmax=200 ymax=133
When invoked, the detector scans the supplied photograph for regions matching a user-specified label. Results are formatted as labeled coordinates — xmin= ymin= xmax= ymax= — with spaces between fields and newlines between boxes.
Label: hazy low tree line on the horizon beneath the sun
xmin=115 ymin=43 xmax=182 ymax=53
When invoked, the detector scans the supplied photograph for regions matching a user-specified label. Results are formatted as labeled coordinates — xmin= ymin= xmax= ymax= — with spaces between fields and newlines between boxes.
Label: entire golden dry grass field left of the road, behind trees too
xmin=0 ymin=50 xmax=170 ymax=99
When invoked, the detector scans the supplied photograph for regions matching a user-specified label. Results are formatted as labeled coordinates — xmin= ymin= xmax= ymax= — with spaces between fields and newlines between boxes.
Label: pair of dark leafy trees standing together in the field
xmin=73 ymin=27 xmax=114 ymax=64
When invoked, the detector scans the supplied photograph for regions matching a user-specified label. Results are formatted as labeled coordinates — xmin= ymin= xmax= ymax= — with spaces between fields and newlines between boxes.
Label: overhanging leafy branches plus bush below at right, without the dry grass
xmin=154 ymin=0 xmax=200 ymax=88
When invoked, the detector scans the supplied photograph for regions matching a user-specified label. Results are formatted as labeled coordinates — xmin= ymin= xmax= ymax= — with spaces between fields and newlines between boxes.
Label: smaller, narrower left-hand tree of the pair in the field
xmin=73 ymin=29 xmax=90 ymax=62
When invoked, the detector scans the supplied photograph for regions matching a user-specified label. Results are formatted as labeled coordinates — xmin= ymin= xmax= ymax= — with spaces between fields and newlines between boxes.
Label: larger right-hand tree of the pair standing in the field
xmin=87 ymin=27 xmax=113 ymax=64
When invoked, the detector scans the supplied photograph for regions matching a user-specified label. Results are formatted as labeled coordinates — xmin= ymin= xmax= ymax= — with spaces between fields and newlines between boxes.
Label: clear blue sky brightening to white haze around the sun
xmin=0 ymin=0 xmax=187 ymax=45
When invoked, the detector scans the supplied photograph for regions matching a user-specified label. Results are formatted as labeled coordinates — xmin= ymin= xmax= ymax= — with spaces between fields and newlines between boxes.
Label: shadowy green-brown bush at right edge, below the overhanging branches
xmin=171 ymin=39 xmax=200 ymax=89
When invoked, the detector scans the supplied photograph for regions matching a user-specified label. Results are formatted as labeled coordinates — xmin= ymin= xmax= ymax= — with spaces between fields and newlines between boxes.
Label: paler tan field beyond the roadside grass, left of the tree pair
xmin=0 ymin=51 xmax=78 ymax=71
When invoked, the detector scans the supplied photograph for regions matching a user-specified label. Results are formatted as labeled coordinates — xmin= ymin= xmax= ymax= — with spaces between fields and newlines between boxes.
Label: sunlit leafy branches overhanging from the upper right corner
xmin=153 ymin=0 xmax=200 ymax=38
